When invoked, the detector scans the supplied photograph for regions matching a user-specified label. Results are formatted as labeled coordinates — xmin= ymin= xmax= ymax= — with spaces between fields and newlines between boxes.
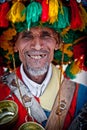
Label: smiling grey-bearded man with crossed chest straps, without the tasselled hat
xmin=0 ymin=0 xmax=87 ymax=130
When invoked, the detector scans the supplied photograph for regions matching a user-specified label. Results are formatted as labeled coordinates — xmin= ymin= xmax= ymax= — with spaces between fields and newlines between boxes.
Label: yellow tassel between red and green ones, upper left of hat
xmin=7 ymin=1 xmax=25 ymax=23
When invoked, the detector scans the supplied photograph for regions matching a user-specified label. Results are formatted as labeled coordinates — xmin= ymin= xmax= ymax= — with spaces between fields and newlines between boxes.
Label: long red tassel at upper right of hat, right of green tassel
xmin=70 ymin=0 xmax=83 ymax=29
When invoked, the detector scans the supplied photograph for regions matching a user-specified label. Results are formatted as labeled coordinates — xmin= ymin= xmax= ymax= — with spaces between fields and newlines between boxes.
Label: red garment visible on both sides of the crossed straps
xmin=0 ymin=68 xmax=78 ymax=130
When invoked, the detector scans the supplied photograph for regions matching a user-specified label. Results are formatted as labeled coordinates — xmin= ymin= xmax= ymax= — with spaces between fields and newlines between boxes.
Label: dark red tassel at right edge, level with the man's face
xmin=73 ymin=36 xmax=87 ymax=71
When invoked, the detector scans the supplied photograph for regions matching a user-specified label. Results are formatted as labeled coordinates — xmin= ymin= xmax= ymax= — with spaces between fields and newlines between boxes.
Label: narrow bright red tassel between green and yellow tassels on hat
xmin=41 ymin=0 xmax=49 ymax=22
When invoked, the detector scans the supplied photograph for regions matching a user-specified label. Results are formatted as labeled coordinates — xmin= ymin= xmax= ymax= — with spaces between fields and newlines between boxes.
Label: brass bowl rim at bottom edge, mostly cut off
xmin=18 ymin=122 xmax=45 ymax=130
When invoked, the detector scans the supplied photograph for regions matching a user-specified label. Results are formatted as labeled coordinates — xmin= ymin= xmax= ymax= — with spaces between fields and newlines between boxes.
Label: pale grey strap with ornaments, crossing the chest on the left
xmin=2 ymin=73 xmax=47 ymax=123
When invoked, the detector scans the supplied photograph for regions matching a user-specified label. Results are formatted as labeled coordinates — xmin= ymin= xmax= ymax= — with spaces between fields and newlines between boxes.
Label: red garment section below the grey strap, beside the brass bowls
xmin=0 ymin=84 xmax=31 ymax=130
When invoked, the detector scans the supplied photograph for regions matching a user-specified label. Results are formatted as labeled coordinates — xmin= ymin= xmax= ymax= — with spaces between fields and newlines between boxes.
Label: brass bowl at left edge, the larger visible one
xmin=0 ymin=100 xmax=18 ymax=130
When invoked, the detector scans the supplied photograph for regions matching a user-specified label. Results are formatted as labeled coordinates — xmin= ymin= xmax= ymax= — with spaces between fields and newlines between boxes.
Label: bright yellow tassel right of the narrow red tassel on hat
xmin=49 ymin=0 xmax=59 ymax=23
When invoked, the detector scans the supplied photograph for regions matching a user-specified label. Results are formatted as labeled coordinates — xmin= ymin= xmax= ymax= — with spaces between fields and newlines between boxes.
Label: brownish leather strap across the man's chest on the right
xmin=45 ymin=79 xmax=75 ymax=130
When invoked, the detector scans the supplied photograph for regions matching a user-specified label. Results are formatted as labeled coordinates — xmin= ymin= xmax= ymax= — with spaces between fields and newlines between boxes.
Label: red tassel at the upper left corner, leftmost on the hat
xmin=0 ymin=2 xmax=10 ymax=27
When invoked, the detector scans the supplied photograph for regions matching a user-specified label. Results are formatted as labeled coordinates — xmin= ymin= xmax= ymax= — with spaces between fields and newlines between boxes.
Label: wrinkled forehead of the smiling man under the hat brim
xmin=14 ymin=26 xmax=61 ymax=44
